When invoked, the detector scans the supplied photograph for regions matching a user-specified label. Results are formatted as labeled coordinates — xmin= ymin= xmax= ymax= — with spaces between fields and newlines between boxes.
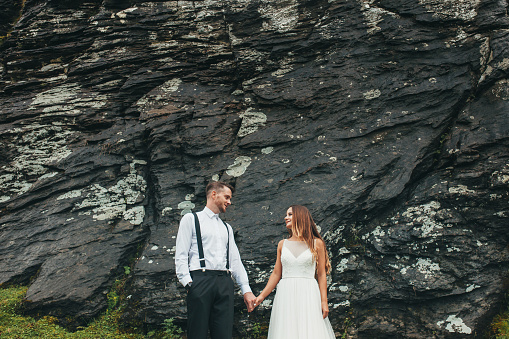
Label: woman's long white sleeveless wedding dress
xmin=267 ymin=240 xmax=336 ymax=339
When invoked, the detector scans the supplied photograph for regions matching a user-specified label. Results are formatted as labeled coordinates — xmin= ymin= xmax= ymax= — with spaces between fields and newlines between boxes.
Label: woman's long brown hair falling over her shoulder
xmin=288 ymin=205 xmax=331 ymax=274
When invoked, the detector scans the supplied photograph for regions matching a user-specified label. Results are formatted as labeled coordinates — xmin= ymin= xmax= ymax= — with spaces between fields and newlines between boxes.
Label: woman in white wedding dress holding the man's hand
xmin=254 ymin=205 xmax=335 ymax=339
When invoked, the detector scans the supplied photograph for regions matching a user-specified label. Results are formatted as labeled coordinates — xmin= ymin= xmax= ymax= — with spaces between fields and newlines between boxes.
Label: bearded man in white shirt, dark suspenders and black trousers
xmin=175 ymin=181 xmax=255 ymax=339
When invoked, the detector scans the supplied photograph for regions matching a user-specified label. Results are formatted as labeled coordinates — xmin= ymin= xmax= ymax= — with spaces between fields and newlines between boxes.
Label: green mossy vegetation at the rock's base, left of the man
xmin=0 ymin=282 xmax=182 ymax=339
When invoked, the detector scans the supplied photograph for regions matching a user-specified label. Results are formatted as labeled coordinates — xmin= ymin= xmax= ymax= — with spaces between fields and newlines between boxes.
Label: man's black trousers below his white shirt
xmin=187 ymin=271 xmax=233 ymax=339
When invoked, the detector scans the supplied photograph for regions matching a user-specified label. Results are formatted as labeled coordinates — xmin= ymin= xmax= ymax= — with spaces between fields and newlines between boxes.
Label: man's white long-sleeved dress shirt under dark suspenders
xmin=175 ymin=207 xmax=251 ymax=294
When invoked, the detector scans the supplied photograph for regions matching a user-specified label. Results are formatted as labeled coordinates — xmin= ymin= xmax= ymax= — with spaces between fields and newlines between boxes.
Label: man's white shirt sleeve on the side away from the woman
xmin=175 ymin=213 xmax=193 ymax=286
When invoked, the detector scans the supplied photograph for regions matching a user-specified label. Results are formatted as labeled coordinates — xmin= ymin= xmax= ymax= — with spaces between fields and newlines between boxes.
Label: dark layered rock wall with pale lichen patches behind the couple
xmin=0 ymin=0 xmax=509 ymax=338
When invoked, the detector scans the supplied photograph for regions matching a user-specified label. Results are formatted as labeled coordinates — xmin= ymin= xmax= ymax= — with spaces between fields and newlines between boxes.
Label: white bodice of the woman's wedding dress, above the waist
xmin=281 ymin=240 xmax=316 ymax=279
